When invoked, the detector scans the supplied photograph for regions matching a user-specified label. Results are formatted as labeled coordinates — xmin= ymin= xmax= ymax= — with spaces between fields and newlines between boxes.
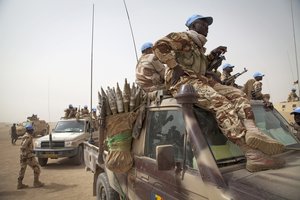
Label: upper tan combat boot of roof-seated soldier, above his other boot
xmin=243 ymin=119 xmax=284 ymax=155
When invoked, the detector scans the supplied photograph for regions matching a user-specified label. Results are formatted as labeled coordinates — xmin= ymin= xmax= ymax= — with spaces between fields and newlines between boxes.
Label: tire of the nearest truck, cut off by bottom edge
xmin=96 ymin=173 xmax=120 ymax=200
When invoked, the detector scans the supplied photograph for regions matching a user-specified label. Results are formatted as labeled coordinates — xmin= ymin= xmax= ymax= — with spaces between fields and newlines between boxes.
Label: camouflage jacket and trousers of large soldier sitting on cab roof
xmin=153 ymin=32 xmax=248 ymax=140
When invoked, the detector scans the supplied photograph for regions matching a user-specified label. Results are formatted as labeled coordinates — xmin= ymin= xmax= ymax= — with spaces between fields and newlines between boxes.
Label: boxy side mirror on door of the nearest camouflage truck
xmin=156 ymin=145 xmax=175 ymax=170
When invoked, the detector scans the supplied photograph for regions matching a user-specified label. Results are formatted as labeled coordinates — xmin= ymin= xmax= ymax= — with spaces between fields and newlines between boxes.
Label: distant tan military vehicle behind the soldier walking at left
xmin=16 ymin=114 xmax=50 ymax=137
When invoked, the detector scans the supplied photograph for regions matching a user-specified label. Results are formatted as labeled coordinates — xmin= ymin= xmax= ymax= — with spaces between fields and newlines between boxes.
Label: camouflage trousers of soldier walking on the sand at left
xmin=18 ymin=155 xmax=41 ymax=181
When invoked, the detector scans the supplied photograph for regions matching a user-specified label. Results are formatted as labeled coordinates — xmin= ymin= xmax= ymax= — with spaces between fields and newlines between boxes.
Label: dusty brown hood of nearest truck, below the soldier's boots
xmin=223 ymin=150 xmax=300 ymax=200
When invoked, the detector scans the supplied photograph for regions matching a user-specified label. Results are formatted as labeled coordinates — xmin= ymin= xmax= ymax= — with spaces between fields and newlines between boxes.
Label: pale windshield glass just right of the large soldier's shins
xmin=252 ymin=105 xmax=297 ymax=145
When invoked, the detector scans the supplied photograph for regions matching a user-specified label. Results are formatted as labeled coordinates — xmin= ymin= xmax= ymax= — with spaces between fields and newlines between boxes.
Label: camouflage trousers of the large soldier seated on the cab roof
xmin=170 ymin=76 xmax=246 ymax=141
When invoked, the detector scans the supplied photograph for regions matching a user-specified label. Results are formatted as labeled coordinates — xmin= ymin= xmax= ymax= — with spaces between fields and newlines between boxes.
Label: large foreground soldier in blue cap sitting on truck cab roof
xmin=153 ymin=15 xmax=285 ymax=172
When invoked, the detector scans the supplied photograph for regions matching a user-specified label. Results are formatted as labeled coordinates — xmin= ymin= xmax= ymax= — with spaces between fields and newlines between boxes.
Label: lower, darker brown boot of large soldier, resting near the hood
xmin=237 ymin=141 xmax=285 ymax=172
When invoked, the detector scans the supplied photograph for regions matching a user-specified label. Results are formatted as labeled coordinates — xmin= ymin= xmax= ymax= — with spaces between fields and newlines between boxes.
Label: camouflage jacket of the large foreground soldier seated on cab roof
xmin=153 ymin=32 xmax=213 ymax=88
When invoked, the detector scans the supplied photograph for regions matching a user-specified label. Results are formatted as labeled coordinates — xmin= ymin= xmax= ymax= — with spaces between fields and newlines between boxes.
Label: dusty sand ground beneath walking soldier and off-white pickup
xmin=0 ymin=123 xmax=96 ymax=200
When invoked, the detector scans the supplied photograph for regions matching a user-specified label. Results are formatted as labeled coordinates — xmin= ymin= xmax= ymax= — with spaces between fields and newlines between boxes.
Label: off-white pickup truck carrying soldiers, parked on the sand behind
xmin=34 ymin=117 xmax=98 ymax=166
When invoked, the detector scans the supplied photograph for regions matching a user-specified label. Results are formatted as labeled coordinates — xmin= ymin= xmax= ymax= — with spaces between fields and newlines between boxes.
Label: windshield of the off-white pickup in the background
xmin=54 ymin=121 xmax=84 ymax=133
